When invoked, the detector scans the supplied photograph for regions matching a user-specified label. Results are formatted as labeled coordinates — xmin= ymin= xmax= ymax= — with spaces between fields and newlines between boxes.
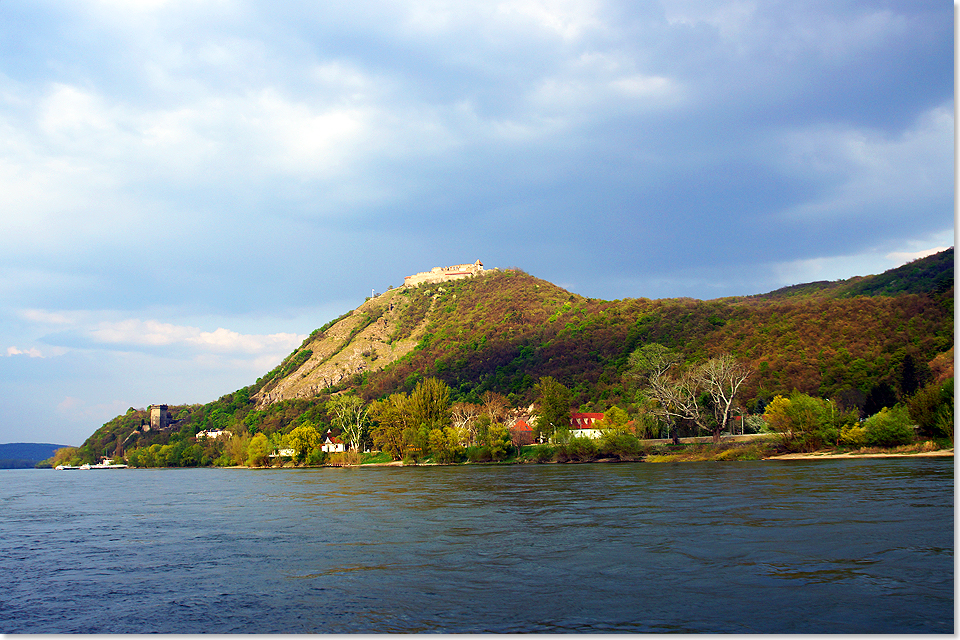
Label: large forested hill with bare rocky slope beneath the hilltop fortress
xmin=82 ymin=248 xmax=953 ymax=455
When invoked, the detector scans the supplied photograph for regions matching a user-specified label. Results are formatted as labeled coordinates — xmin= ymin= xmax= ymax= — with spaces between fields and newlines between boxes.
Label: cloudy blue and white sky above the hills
xmin=0 ymin=0 xmax=955 ymax=445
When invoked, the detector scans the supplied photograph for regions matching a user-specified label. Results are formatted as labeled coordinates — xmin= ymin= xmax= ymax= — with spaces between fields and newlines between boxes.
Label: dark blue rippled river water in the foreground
xmin=0 ymin=458 xmax=954 ymax=633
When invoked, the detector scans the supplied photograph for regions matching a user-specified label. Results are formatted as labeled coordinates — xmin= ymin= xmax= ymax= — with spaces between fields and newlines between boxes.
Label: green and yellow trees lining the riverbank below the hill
xmin=107 ymin=344 xmax=953 ymax=467
